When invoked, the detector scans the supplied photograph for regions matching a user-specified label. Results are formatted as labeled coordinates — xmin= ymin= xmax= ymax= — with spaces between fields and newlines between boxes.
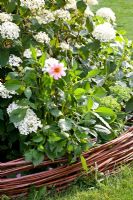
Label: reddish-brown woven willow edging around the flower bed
xmin=0 ymin=127 xmax=133 ymax=196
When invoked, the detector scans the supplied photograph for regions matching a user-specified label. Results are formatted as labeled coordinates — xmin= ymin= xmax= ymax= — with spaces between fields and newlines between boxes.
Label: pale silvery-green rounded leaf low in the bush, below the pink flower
xmin=58 ymin=119 xmax=72 ymax=131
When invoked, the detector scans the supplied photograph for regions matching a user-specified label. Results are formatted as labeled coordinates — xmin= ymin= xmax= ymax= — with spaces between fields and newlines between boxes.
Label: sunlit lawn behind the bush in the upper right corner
xmin=95 ymin=0 xmax=133 ymax=39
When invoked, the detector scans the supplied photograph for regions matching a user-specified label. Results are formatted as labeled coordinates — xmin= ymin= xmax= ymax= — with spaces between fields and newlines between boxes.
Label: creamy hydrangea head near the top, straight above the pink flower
xmin=54 ymin=9 xmax=71 ymax=20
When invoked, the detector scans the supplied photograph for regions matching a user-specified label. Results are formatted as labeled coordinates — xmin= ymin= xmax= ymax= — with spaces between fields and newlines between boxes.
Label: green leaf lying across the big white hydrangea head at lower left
xmin=10 ymin=108 xmax=27 ymax=123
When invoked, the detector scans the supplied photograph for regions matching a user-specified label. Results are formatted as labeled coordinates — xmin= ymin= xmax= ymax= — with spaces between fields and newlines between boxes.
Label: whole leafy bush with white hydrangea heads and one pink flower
xmin=0 ymin=0 xmax=133 ymax=165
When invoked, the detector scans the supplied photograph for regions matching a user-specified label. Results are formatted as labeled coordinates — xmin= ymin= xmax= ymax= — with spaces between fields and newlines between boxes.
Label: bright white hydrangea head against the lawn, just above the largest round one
xmin=96 ymin=7 xmax=116 ymax=22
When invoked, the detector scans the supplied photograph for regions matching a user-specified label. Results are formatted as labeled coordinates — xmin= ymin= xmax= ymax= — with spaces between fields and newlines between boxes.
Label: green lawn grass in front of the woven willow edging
xmin=47 ymin=166 xmax=133 ymax=200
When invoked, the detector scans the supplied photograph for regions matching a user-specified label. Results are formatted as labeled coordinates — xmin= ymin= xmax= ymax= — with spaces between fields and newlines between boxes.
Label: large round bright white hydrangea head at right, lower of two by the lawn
xmin=92 ymin=22 xmax=116 ymax=42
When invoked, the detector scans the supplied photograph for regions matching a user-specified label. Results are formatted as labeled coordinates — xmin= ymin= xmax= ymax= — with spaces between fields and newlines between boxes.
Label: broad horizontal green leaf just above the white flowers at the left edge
xmin=5 ymin=80 xmax=21 ymax=90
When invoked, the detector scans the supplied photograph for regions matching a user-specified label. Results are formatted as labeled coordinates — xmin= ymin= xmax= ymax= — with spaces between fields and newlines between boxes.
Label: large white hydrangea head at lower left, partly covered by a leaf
xmin=7 ymin=102 xmax=42 ymax=135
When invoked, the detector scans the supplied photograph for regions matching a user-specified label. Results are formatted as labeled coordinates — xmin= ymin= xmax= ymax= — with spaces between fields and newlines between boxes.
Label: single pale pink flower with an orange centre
xmin=47 ymin=63 xmax=66 ymax=80
